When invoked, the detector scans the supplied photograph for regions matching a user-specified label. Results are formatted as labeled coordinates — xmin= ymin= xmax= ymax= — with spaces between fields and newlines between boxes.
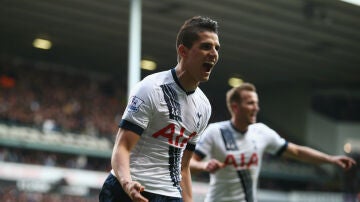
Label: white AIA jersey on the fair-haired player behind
xmin=195 ymin=121 xmax=287 ymax=202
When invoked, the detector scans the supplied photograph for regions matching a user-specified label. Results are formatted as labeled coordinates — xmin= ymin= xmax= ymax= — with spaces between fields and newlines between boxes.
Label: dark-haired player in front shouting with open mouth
xmin=99 ymin=16 xmax=220 ymax=202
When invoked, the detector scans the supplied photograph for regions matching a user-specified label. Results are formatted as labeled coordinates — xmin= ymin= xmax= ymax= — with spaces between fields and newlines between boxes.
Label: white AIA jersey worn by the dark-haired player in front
xmin=114 ymin=69 xmax=211 ymax=197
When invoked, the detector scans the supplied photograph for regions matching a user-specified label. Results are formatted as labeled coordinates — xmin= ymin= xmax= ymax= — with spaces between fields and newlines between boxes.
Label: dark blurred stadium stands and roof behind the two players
xmin=0 ymin=0 xmax=360 ymax=202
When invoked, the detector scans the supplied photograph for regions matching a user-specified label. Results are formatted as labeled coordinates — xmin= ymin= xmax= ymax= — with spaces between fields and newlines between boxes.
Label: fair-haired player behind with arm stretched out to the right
xmin=190 ymin=83 xmax=355 ymax=202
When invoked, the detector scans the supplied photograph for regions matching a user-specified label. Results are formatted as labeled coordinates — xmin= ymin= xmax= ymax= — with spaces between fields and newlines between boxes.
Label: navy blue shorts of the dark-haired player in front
xmin=99 ymin=173 xmax=183 ymax=202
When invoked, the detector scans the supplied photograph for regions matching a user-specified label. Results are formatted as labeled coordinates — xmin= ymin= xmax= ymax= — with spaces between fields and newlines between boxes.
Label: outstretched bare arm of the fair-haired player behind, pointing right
xmin=284 ymin=143 xmax=356 ymax=170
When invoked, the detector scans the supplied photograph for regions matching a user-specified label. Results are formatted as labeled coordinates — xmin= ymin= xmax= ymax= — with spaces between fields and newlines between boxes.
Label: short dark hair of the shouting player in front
xmin=176 ymin=16 xmax=218 ymax=48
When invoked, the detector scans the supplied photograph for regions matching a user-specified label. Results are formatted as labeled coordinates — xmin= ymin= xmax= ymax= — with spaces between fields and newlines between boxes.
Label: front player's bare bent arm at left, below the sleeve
xmin=111 ymin=128 xmax=148 ymax=202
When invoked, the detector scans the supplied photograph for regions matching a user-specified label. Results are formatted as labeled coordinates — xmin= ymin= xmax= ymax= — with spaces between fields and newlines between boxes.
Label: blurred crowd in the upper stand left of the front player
xmin=0 ymin=59 xmax=125 ymax=135
